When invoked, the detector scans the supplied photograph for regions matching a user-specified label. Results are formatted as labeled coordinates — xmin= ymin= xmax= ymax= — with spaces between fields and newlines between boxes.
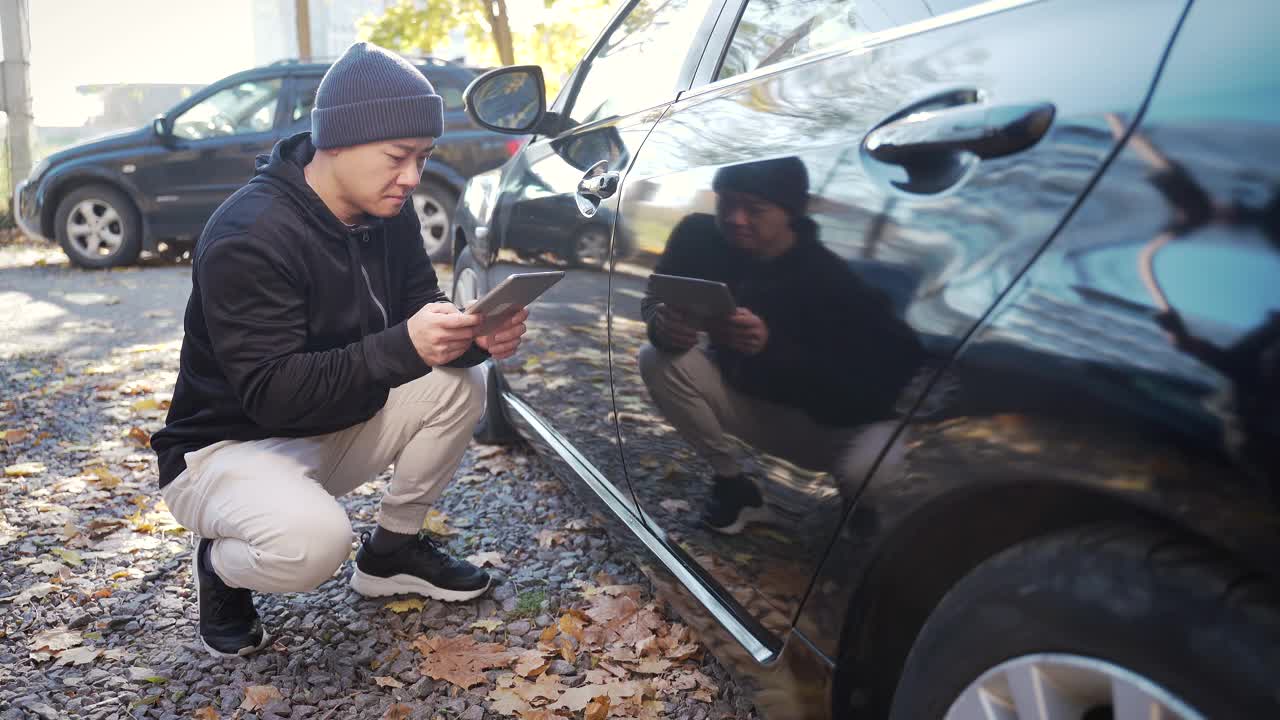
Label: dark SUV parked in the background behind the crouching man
xmin=14 ymin=59 xmax=520 ymax=268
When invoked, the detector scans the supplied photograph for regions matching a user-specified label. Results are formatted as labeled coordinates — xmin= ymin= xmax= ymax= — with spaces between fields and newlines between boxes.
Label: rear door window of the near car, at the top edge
xmin=716 ymin=0 xmax=980 ymax=79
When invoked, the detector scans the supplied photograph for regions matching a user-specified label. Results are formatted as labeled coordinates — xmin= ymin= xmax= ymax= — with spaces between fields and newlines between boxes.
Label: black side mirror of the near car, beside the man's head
xmin=462 ymin=65 xmax=556 ymax=135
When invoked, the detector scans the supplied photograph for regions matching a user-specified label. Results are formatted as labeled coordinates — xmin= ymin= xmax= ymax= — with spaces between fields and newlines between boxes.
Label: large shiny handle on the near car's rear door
xmin=863 ymin=102 xmax=1055 ymax=165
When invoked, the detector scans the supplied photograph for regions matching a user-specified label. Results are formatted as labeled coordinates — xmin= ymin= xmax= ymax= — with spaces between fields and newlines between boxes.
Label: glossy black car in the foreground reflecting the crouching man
xmin=453 ymin=0 xmax=1280 ymax=720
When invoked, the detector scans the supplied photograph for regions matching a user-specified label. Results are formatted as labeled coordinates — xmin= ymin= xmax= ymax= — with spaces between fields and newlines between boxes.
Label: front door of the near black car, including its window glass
xmin=470 ymin=0 xmax=719 ymax=515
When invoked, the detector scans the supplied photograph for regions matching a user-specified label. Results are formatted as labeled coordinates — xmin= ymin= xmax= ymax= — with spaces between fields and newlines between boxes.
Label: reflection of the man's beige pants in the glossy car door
xmin=640 ymin=345 xmax=897 ymax=483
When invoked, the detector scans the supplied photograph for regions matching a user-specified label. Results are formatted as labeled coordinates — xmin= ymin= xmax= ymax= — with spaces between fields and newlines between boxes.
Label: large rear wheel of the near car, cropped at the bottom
xmin=891 ymin=525 xmax=1280 ymax=720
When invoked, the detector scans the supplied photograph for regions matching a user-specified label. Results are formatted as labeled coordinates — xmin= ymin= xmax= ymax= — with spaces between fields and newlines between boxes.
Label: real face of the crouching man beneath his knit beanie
xmin=334 ymin=137 xmax=434 ymax=218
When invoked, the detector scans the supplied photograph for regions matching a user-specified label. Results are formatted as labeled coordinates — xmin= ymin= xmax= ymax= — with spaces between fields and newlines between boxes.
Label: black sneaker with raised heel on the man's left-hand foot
xmin=191 ymin=538 xmax=268 ymax=657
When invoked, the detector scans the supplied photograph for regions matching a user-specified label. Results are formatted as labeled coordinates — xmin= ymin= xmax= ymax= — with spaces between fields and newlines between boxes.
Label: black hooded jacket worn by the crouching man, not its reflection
xmin=151 ymin=133 xmax=486 ymax=487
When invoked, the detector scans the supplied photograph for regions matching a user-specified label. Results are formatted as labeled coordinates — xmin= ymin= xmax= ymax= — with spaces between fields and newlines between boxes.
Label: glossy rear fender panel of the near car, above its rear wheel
xmin=797 ymin=3 xmax=1280 ymax=716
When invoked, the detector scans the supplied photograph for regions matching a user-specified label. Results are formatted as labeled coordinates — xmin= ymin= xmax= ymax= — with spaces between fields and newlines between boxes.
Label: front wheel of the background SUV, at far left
xmin=54 ymin=184 xmax=142 ymax=269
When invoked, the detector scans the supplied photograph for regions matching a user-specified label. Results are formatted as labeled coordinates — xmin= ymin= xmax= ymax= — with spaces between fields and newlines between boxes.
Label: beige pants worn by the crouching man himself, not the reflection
xmin=161 ymin=368 xmax=484 ymax=592
